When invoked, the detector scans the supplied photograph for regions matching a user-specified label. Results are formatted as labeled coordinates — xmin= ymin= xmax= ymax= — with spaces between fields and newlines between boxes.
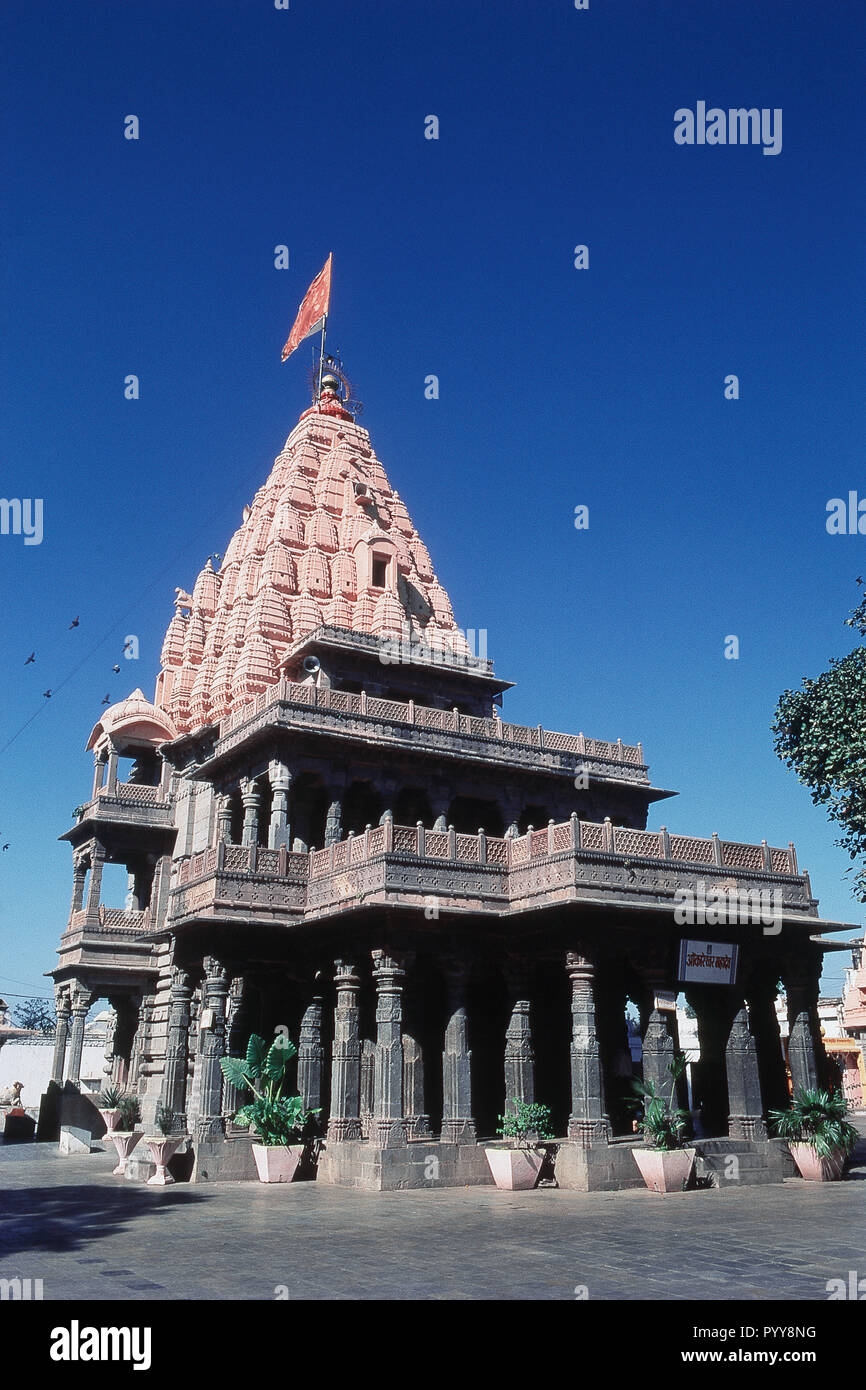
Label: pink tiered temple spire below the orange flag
xmin=152 ymin=391 xmax=468 ymax=734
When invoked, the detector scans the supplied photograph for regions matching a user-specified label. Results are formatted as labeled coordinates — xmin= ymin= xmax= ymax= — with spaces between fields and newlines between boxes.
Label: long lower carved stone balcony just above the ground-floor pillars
xmin=168 ymin=816 xmax=819 ymax=930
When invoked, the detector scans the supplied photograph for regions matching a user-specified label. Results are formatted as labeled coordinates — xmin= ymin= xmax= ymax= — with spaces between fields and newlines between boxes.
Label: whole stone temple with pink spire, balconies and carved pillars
xmin=43 ymin=375 xmax=856 ymax=1190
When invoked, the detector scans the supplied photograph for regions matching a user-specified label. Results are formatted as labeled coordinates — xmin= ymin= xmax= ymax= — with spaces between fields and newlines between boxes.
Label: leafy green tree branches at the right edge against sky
xmin=773 ymin=578 xmax=866 ymax=902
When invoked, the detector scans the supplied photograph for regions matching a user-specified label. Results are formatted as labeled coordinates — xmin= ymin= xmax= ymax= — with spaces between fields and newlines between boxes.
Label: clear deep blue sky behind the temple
xmin=0 ymin=0 xmax=866 ymax=997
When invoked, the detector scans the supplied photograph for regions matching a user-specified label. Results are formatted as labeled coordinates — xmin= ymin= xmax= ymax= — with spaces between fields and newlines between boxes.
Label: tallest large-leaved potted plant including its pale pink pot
xmin=220 ymin=1033 xmax=320 ymax=1183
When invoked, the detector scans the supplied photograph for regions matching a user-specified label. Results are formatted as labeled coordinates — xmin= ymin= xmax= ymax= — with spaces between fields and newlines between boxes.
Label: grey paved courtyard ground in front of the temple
xmin=0 ymin=1120 xmax=866 ymax=1301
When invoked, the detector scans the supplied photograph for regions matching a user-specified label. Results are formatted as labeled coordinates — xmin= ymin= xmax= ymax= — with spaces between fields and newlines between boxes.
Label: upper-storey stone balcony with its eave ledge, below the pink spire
xmin=199 ymin=681 xmax=664 ymax=801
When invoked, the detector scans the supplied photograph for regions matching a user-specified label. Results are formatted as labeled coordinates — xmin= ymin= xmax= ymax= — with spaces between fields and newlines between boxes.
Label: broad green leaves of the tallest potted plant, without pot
xmin=220 ymin=1033 xmax=320 ymax=1147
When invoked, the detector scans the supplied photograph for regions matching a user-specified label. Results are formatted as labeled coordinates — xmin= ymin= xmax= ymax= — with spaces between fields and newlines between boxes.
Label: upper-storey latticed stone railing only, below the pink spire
xmin=220 ymin=681 xmax=645 ymax=769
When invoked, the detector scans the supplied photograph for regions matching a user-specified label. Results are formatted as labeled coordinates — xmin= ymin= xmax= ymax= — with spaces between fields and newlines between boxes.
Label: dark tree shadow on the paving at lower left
xmin=0 ymin=1183 xmax=207 ymax=1258
